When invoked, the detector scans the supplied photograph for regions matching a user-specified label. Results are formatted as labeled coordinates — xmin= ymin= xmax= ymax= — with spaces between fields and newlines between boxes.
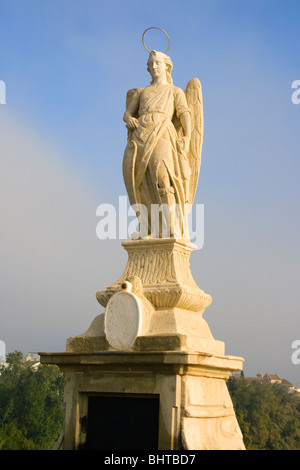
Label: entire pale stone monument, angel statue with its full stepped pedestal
xmin=40 ymin=28 xmax=245 ymax=452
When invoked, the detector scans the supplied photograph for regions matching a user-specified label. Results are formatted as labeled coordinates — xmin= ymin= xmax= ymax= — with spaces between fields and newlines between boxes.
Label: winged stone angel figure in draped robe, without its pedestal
xmin=123 ymin=28 xmax=203 ymax=239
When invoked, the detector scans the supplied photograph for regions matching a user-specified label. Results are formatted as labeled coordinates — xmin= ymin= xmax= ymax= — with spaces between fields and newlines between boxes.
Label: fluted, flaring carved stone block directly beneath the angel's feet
xmin=96 ymin=238 xmax=212 ymax=313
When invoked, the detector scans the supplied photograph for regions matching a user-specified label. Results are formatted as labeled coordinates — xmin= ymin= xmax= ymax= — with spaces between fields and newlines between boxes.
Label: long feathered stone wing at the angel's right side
xmin=185 ymin=78 xmax=203 ymax=205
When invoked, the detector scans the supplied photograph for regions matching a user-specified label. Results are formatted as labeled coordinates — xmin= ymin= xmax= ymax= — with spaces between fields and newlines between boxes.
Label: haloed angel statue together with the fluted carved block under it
xmin=96 ymin=28 xmax=212 ymax=314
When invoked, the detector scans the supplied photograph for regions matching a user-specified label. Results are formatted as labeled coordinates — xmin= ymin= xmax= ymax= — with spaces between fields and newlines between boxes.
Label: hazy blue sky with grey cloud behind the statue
xmin=0 ymin=0 xmax=300 ymax=387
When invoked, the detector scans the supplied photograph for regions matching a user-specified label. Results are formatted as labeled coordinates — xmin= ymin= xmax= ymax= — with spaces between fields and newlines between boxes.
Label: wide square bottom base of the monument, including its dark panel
xmin=40 ymin=348 xmax=245 ymax=451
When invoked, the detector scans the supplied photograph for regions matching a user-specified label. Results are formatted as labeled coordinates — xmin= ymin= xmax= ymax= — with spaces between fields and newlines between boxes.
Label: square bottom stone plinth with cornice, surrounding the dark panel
xmin=40 ymin=351 xmax=244 ymax=451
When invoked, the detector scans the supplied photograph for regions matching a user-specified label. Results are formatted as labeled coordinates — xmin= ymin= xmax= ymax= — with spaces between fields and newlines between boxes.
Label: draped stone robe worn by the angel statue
xmin=123 ymin=84 xmax=190 ymax=239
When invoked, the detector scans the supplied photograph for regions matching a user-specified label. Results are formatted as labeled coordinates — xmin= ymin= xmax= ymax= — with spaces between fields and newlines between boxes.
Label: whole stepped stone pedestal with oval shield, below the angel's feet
xmin=40 ymin=239 xmax=244 ymax=451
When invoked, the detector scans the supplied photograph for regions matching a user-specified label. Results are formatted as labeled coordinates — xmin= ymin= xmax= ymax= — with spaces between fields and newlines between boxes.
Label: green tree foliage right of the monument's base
xmin=228 ymin=376 xmax=300 ymax=450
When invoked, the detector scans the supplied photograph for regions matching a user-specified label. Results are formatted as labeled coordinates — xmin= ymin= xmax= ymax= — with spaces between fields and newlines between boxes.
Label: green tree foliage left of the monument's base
xmin=0 ymin=351 xmax=64 ymax=450
